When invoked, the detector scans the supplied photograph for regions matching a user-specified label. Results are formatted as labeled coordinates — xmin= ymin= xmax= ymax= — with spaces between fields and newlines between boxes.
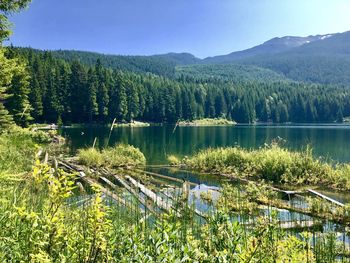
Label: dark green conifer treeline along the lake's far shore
xmin=5 ymin=48 xmax=350 ymax=125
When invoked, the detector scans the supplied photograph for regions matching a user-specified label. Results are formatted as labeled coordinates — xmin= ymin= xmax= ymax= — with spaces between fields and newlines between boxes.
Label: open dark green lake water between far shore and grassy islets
xmin=60 ymin=125 xmax=350 ymax=164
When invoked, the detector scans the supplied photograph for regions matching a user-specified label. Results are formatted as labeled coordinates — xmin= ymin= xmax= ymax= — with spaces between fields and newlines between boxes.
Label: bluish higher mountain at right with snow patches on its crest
xmin=202 ymin=32 xmax=350 ymax=86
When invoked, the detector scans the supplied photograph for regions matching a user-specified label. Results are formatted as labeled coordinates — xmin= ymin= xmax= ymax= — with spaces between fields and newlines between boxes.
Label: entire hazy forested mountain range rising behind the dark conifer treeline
xmin=15 ymin=31 xmax=350 ymax=86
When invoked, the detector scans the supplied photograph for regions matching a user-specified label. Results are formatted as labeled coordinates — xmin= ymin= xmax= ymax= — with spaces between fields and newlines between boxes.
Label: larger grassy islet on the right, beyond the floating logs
xmin=185 ymin=144 xmax=350 ymax=190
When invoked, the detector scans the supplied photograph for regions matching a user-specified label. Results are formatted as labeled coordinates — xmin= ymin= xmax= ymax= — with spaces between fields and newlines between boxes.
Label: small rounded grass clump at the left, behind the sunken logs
xmin=78 ymin=144 xmax=146 ymax=168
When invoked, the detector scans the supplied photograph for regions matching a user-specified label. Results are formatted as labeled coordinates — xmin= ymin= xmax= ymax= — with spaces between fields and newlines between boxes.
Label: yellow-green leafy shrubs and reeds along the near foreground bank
xmin=0 ymin=158 xmax=315 ymax=262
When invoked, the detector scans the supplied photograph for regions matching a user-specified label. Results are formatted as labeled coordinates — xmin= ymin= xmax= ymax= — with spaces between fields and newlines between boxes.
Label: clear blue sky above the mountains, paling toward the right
xmin=6 ymin=0 xmax=350 ymax=57
